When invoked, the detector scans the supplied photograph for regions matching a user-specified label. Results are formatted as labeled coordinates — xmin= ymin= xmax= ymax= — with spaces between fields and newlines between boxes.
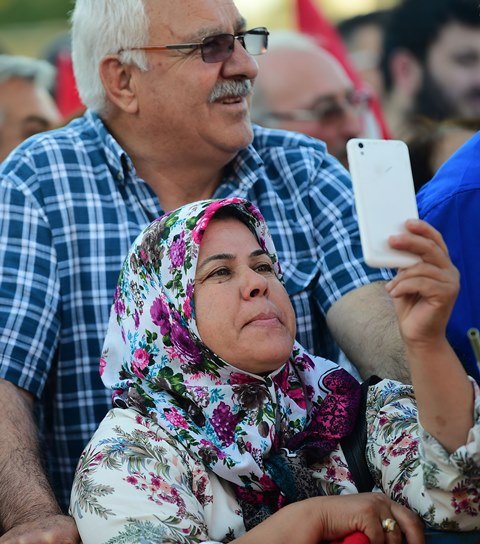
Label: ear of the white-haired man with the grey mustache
xmin=100 ymin=55 xmax=138 ymax=113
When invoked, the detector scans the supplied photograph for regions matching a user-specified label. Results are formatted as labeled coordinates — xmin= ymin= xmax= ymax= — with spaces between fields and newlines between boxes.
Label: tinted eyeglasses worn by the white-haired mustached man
xmin=119 ymin=27 xmax=269 ymax=63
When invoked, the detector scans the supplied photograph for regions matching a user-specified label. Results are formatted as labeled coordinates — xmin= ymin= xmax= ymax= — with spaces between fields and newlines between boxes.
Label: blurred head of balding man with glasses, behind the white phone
xmin=252 ymin=31 xmax=368 ymax=166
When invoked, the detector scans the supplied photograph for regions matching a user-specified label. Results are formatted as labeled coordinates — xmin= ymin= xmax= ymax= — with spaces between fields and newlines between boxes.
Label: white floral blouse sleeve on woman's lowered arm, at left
xmin=70 ymin=409 xmax=244 ymax=544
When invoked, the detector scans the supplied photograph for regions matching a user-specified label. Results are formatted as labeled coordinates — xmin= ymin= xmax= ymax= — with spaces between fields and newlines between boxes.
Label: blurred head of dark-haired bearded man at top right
xmin=382 ymin=0 xmax=480 ymax=139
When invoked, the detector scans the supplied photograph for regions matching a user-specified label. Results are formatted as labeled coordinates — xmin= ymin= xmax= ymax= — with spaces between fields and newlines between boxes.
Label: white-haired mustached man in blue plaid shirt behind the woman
xmin=0 ymin=0 xmax=407 ymax=544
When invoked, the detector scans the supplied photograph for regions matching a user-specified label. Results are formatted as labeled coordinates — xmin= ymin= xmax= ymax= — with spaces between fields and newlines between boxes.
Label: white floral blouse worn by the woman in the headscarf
xmin=70 ymin=380 xmax=480 ymax=544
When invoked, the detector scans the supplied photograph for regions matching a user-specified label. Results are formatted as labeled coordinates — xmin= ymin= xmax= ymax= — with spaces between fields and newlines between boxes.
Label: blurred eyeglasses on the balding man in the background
xmin=268 ymin=89 xmax=372 ymax=125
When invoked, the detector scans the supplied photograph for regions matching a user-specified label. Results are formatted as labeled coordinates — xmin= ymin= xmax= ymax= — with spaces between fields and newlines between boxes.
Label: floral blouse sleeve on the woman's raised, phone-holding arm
xmin=367 ymin=380 xmax=480 ymax=531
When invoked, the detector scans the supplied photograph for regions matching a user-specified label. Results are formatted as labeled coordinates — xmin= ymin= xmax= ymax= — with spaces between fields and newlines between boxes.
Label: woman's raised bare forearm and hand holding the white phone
xmin=386 ymin=220 xmax=474 ymax=453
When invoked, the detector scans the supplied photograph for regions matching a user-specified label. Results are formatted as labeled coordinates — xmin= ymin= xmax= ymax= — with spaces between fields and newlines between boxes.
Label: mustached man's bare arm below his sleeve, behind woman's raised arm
xmin=327 ymin=282 xmax=410 ymax=383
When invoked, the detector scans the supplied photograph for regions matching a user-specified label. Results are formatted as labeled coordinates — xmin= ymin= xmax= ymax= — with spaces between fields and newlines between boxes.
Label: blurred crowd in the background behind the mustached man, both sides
xmin=0 ymin=0 xmax=480 ymax=189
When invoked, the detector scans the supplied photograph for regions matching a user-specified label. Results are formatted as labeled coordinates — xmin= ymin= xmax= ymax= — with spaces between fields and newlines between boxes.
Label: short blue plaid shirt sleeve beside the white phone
xmin=306 ymin=154 xmax=393 ymax=314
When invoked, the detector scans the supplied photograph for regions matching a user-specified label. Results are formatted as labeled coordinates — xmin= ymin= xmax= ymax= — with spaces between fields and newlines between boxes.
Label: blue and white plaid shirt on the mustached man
xmin=0 ymin=112 xmax=389 ymax=507
